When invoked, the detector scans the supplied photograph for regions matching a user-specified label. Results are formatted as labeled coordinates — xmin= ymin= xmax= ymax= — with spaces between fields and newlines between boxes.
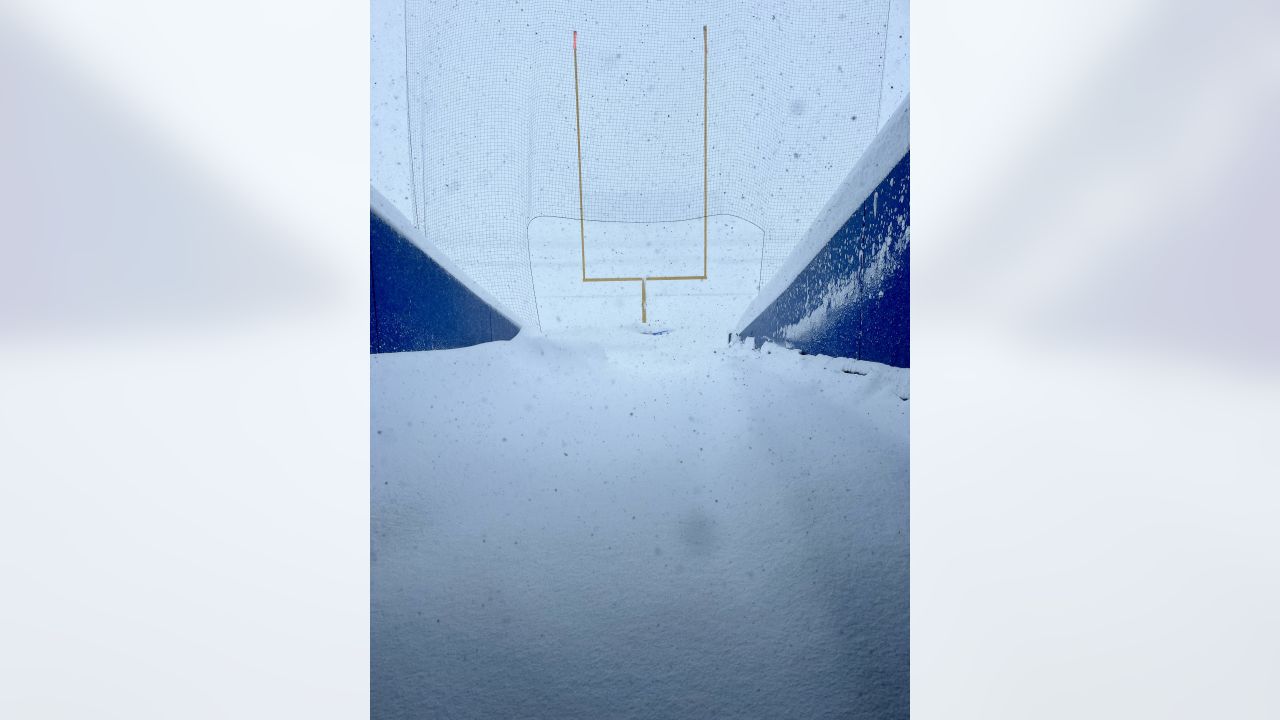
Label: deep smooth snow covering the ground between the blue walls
xmin=371 ymin=324 xmax=910 ymax=719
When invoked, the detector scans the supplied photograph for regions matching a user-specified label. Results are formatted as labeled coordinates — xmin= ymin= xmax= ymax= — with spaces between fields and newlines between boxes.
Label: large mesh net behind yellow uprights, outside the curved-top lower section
xmin=404 ymin=0 xmax=888 ymax=325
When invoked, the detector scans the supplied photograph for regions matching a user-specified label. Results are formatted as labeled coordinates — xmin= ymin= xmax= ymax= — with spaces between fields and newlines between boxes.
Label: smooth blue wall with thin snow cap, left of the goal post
xmin=369 ymin=190 xmax=520 ymax=354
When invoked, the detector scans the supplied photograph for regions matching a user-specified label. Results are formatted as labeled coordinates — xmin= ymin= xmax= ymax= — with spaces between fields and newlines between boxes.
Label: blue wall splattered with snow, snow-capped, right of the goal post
xmin=737 ymin=97 xmax=911 ymax=368
